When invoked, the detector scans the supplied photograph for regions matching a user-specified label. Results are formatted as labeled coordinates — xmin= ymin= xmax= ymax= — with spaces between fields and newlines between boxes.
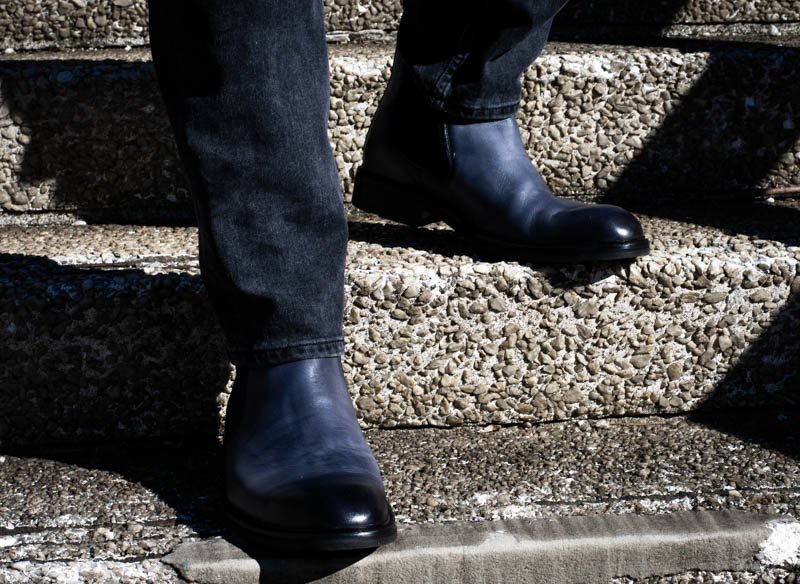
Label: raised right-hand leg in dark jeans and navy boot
xmin=353 ymin=0 xmax=649 ymax=261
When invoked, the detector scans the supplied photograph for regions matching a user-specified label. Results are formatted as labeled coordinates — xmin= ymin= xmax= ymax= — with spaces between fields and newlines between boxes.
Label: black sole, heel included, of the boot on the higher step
xmin=353 ymin=170 xmax=650 ymax=263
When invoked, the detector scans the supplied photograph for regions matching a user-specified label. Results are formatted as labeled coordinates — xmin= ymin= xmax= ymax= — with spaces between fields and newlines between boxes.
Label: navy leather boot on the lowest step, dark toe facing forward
xmin=225 ymin=357 xmax=397 ymax=552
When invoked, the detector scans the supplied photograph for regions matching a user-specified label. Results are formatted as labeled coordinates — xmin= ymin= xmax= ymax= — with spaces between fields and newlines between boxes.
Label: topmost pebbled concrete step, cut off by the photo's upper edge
xmin=0 ymin=0 xmax=800 ymax=50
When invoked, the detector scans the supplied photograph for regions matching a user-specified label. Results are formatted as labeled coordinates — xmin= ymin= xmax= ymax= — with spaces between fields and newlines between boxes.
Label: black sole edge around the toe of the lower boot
xmin=225 ymin=504 xmax=397 ymax=553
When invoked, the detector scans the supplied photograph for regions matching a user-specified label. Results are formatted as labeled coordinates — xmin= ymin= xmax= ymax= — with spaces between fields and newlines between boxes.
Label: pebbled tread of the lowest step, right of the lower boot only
xmin=371 ymin=412 xmax=800 ymax=523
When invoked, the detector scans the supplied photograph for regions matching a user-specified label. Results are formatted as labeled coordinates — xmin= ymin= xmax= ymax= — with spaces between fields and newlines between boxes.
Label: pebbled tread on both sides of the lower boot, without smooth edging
xmin=0 ymin=411 xmax=800 ymax=574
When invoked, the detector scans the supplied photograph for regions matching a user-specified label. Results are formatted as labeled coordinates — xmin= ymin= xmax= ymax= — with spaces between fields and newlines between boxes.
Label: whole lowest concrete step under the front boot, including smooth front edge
xmin=0 ymin=410 xmax=800 ymax=584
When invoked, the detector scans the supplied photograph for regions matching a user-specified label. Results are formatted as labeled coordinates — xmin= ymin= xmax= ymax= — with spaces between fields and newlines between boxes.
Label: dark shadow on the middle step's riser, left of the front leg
xmin=0 ymin=254 xmax=229 ymax=445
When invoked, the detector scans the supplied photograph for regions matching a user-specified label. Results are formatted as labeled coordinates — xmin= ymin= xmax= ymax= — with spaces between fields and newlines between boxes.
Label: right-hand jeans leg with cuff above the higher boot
xmin=398 ymin=0 xmax=567 ymax=121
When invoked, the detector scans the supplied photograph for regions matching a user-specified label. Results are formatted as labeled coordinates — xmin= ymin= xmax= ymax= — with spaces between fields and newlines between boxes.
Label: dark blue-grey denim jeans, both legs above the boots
xmin=149 ymin=0 xmax=566 ymax=365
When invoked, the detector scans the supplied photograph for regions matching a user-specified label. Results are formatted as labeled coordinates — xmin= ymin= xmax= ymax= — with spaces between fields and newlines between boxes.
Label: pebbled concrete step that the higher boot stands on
xmin=0 ymin=204 xmax=800 ymax=444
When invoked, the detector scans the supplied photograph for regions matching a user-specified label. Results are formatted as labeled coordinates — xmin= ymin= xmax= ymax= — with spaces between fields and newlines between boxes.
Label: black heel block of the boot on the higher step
xmin=353 ymin=172 xmax=438 ymax=227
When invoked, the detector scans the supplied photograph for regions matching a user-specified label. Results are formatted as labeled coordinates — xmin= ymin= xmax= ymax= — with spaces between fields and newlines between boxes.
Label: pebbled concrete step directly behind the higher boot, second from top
xmin=0 ymin=44 xmax=800 ymax=223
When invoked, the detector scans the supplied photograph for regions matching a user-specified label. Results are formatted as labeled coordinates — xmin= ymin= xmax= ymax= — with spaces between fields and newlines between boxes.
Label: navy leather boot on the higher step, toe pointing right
xmin=353 ymin=54 xmax=650 ymax=262
